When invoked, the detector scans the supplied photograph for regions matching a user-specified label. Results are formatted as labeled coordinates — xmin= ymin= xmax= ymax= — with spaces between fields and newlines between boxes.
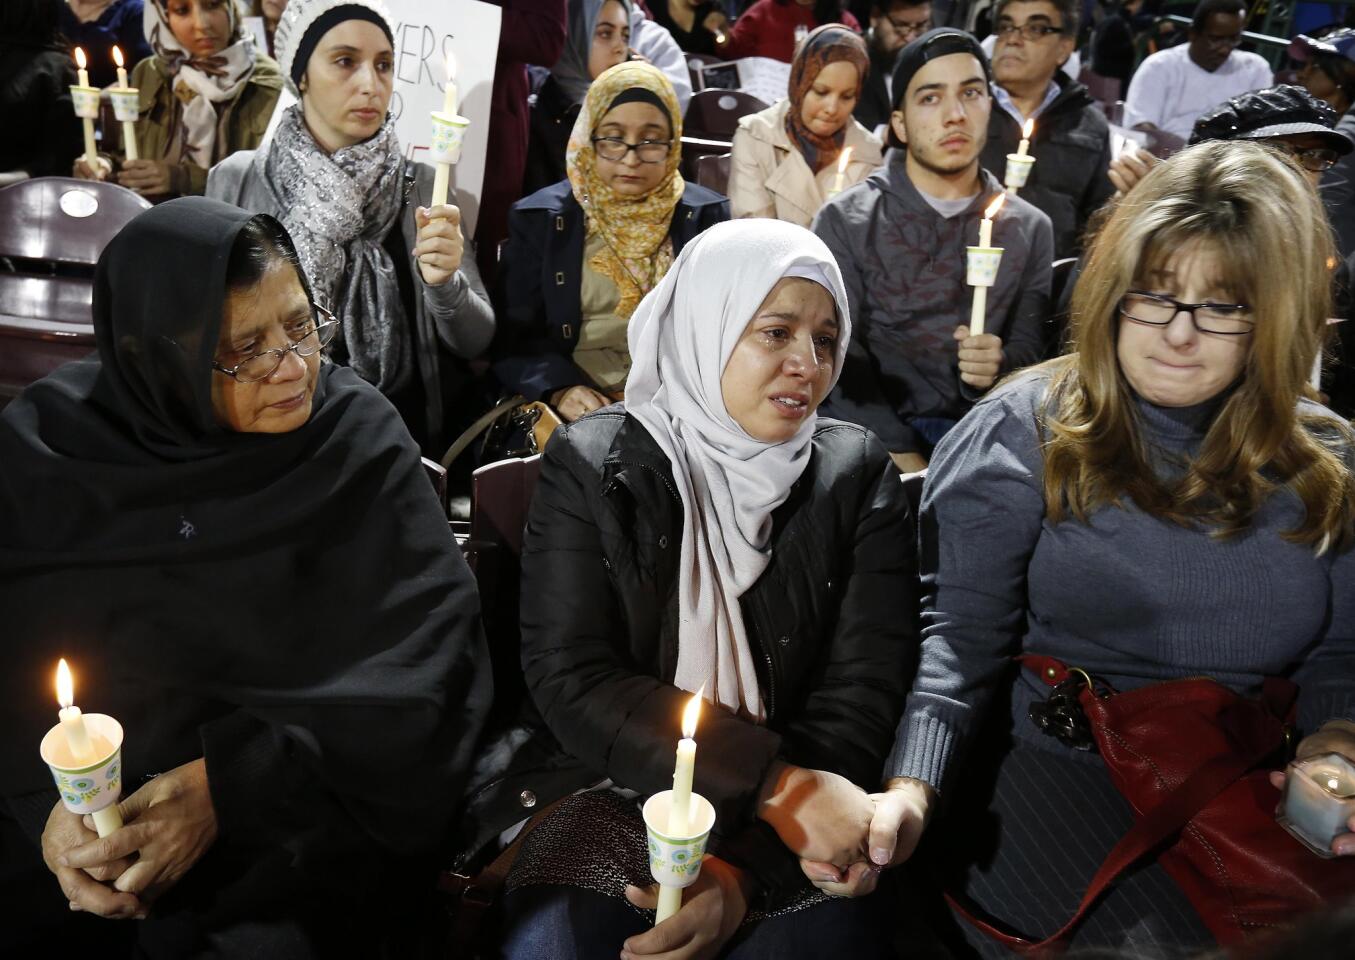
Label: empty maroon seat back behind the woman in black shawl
xmin=0 ymin=176 xmax=150 ymax=396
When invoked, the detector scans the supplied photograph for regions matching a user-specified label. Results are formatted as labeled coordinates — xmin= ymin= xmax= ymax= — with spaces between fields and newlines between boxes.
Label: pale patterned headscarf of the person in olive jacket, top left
xmin=141 ymin=0 xmax=255 ymax=167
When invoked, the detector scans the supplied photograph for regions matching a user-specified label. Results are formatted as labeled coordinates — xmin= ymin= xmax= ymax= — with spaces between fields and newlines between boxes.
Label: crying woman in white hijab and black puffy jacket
xmin=466 ymin=220 xmax=917 ymax=957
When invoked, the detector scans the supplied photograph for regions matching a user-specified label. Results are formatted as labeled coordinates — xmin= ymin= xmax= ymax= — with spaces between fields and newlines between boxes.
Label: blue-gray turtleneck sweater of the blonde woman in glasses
xmin=885 ymin=373 xmax=1355 ymax=789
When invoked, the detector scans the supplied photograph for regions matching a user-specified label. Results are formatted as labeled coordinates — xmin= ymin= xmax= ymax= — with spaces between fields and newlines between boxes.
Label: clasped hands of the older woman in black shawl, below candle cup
xmin=49 ymin=758 xmax=217 ymax=917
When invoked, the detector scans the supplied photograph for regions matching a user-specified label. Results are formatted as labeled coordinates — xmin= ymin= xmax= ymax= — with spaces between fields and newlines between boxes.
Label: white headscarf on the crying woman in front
xmin=626 ymin=220 xmax=851 ymax=720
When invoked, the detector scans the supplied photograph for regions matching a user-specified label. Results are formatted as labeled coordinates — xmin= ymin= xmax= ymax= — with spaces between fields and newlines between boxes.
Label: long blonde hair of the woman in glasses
xmin=1042 ymin=142 xmax=1355 ymax=552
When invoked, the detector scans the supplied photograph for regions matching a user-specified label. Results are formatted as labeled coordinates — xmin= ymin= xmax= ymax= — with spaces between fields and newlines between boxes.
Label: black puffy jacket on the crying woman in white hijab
xmin=461 ymin=405 xmax=919 ymax=902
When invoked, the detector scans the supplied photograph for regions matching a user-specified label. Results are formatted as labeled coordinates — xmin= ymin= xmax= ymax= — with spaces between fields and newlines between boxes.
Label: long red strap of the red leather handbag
xmin=946 ymin=655 xmax=1279 ymax=953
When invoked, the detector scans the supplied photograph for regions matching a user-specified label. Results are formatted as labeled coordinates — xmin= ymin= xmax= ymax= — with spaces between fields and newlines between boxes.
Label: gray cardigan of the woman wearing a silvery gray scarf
xmin=207 ymin=148 xmax=495 ymax=447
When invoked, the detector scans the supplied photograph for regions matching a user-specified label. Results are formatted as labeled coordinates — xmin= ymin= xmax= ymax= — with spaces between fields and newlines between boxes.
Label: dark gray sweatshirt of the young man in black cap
xmin=813 ymin=149 xmax=1054 ymax=453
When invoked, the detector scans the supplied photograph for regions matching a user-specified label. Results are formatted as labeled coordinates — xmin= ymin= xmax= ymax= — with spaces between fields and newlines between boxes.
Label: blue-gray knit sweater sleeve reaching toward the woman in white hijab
xmin=885 ymin=376 xmax=1047 ymax=791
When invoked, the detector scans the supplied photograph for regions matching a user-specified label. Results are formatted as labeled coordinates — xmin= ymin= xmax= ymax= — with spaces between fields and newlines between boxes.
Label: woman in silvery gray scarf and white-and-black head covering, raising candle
xmin=207 ymin=0 xmax=495 ymax=456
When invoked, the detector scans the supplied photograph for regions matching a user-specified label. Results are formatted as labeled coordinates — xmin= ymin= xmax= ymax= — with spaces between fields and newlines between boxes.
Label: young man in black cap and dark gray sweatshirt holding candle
xmin=813 ymin=28 xmax=1054 ymax=471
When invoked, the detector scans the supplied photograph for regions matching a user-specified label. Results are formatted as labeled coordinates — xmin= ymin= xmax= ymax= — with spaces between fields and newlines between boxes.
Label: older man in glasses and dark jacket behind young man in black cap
xmin=981 ymin=0 xmax=1114 ymax=258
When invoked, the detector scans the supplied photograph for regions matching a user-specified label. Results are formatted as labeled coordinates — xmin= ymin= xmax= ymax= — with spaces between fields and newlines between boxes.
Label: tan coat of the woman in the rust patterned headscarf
xmin=729 ymin=99 xmax=883 ymax=226
